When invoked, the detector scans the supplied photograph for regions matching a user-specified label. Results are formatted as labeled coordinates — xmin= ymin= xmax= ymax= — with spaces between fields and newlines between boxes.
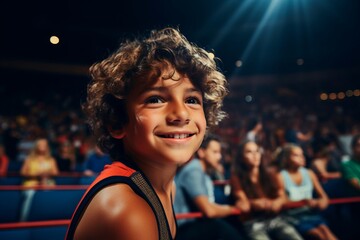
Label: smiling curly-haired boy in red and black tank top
xmin=67 ymin=28 xmax=227 ymax=240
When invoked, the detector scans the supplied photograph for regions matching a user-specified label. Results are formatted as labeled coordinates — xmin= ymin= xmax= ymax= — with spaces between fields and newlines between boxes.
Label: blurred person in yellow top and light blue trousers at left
xmin=20 ymin=138 xmax=59 ymax=221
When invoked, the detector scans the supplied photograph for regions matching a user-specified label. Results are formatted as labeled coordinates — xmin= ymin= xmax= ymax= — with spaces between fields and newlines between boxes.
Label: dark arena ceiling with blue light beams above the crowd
xmin=0 ymin=0 xmax=360 ymax=98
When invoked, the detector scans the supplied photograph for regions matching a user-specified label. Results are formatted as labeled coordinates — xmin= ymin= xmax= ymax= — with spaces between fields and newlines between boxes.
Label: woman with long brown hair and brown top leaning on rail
xmin=231 ymin=141 xmax=302 ymax=240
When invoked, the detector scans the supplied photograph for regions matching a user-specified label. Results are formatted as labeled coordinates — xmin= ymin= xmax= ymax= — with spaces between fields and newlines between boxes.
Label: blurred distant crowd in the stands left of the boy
xmin=0 ymin=95 xmax=111 ymax=176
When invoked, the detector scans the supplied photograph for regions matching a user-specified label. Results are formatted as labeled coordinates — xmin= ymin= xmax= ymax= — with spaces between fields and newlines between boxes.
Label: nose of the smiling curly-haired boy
xmin=166 ymin=102 xmax=190 ymax=125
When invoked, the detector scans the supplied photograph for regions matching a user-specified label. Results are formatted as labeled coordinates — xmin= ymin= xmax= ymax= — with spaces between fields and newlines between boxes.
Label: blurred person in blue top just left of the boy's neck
xmin=84 ymin=146 xmax=112 ymax=176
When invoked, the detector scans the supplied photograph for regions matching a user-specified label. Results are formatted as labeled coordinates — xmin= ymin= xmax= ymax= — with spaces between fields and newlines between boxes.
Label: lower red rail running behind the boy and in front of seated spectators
xmin=0 ymin=197 xmax=360 ymax=230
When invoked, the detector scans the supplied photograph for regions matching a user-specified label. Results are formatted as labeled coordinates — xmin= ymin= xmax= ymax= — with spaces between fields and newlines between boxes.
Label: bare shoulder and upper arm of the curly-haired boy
xmin=75 ymin=184 xmax=158 ymax=240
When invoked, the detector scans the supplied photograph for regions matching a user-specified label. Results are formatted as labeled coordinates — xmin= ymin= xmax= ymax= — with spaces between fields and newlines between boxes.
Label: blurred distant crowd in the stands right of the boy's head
xmin=215 ymin=96 xmax=360 ymax=177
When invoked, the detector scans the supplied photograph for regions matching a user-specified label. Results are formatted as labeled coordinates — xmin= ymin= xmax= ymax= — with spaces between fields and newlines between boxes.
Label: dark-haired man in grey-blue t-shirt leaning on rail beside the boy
xmin=174 ymin=134 xmax=241 ymax=240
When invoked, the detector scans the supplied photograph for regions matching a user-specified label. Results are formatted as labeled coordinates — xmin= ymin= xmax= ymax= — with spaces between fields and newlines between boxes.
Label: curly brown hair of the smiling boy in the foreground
xmin=83 ymin=28 xmax=228 ymax=160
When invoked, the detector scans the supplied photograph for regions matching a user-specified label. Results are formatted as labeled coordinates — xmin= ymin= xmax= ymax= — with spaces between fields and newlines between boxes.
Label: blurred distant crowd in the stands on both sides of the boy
xmin=0 ymin=91 xmax=360 ymax=178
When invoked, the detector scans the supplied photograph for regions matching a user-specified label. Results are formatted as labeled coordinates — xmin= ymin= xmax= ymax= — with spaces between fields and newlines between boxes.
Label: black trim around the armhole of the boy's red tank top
xmin=65 ymin=172 xmax=172 ymax=240
